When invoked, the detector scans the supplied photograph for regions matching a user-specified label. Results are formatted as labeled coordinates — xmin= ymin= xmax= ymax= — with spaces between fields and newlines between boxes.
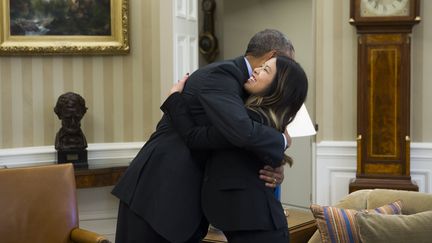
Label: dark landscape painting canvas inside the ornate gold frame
xmin=9 ymin=0 xmax=111 ymax=35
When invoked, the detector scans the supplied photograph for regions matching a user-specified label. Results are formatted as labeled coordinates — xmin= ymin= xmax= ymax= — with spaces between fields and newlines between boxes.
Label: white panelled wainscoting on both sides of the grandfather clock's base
xmin=312 ymin=141 xmax=432 ymax=205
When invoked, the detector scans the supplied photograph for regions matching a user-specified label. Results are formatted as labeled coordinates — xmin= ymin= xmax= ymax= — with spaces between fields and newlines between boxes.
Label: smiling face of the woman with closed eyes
xmin=243 ymin=57 xmax=276 ymax=95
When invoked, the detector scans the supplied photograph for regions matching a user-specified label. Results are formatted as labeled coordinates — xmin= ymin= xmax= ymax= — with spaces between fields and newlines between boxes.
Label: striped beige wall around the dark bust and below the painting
xmin=0 ymin=0 xmax=171 ymax=148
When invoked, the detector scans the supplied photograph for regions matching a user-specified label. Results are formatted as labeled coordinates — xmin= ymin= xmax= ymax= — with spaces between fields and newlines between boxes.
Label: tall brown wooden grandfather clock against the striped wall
xmin=349 ymin=0 xmax=420 ymax=192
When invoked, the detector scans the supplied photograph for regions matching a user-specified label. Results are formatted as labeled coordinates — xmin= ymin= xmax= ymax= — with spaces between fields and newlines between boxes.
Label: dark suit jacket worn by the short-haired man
xmin=112 ymin=57 xmax=284 ymax=242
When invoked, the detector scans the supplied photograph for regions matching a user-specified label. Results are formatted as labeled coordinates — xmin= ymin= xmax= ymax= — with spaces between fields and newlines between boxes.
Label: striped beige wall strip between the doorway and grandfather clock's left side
xmin=315 ymin=0 xmax=357 ymax=141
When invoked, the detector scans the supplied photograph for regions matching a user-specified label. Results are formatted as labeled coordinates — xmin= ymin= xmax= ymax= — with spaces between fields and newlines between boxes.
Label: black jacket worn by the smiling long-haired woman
xmin=162 ymin=93 xmax=287 ymax=231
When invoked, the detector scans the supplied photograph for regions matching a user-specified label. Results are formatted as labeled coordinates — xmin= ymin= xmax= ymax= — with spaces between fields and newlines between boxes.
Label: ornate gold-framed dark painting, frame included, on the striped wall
xmin=0 ymin=0 xmax=130 ymax=55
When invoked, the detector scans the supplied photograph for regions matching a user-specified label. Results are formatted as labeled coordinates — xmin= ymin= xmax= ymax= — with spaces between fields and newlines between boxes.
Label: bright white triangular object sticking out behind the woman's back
xmin=287 ymin=104 xmax=316 ymax=138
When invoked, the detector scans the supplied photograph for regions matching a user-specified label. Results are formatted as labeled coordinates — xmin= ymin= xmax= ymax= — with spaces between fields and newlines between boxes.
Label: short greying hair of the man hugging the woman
xmin=245 ymin=29 xmax=294 ymax=58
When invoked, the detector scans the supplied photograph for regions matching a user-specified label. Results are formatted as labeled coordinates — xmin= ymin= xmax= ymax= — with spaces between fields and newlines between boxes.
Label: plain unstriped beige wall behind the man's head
xmin=216 ymin=0 xmax=315 ymax=129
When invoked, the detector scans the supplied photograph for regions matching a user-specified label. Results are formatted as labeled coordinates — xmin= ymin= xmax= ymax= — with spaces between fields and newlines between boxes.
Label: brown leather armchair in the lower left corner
xmin=0 ymin=164 xmax=109 ymax=243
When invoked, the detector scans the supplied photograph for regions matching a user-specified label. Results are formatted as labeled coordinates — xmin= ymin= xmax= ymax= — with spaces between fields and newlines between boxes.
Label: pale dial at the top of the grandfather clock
xmin=360 ymin=0 xmax=410 ymax=17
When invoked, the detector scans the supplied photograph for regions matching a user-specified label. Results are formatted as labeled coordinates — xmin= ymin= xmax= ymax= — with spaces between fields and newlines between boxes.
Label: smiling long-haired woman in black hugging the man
xmin=161 ymin=56 xmax=308 ymax=243
